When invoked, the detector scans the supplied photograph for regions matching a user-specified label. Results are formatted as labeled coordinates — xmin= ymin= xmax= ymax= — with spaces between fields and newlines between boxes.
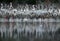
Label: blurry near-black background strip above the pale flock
xmin=0 ymin=0 xmax=60 ymax=4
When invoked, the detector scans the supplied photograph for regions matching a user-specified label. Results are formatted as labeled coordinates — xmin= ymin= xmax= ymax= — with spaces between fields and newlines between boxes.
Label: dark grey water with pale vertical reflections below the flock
xmin=0 ymin=18 xmax=60 ymax=41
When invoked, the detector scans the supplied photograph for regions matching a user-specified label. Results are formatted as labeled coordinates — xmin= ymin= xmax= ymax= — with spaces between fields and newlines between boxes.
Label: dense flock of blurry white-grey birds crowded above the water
xmin=0 ymin=3 xmax=60 ymax=16
